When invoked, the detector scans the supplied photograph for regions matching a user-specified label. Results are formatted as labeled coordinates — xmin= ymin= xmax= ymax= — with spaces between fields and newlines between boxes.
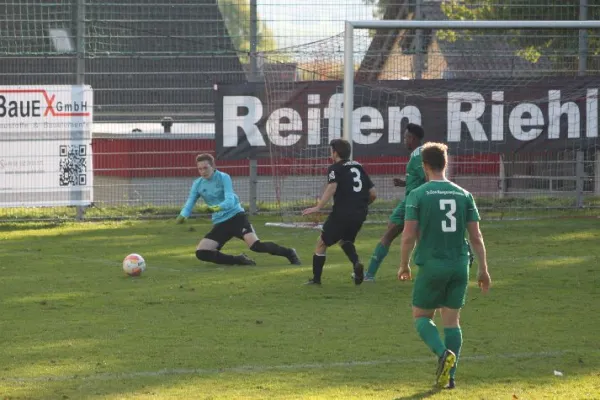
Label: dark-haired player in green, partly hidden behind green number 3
xmin=365 ymin=124 xmax=426 ymax=282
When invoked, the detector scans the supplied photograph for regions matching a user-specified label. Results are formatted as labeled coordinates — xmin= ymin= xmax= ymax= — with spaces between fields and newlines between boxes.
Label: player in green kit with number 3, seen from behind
xmin=398 ymin=143 xmax=491 ymax=389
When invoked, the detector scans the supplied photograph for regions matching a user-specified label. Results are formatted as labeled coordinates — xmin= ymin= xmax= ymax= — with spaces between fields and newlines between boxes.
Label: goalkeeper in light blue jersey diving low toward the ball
xmin=176 ymin=154 xmax=300 ymax=265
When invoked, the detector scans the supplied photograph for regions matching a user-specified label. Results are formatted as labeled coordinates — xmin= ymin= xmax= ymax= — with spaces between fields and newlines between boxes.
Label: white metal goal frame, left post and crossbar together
xmin=342 ymin=20 xmax=600 ymax=147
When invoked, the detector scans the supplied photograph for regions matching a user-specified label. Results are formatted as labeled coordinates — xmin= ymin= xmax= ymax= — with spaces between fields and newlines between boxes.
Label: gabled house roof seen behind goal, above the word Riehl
xmin=357 ymin=0 xmax=552 ymax=81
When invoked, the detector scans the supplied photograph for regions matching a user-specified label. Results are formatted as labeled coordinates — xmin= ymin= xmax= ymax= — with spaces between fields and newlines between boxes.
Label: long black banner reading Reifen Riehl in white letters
xmin=215 ymin=76 xmax=600 ymax=159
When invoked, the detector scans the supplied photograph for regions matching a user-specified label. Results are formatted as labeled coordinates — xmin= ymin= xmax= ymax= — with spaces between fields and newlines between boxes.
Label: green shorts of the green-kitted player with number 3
xmin=413 ymin=265 xmax=469 ymax=310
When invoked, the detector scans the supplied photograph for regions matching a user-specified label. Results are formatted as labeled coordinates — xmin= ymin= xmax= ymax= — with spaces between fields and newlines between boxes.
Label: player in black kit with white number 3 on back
xmin=302 ymin=139 xmax=376 ymax=285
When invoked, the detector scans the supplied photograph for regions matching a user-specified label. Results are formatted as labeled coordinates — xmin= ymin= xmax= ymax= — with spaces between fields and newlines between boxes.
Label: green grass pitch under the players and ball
xmin=0 ymin=218 xmax=600 ymax=399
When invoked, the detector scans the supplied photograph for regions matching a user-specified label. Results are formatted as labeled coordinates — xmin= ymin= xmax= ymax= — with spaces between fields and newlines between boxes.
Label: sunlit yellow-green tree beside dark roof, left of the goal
xmin=218 ymin=0 xmax=276 ymax=63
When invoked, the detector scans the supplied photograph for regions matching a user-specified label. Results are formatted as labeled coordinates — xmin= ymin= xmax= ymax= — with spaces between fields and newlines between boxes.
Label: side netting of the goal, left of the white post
xmin=261 ymin=34 xmax=344 ymax=228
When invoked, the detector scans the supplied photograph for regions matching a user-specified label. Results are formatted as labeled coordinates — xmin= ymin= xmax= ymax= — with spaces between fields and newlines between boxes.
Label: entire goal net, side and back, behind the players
xmin=263 ymin=18 xmax=600 ymax=226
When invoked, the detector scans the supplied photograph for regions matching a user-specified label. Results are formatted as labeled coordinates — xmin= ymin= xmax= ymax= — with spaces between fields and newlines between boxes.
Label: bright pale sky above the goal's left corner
xmin=257 ymin=0 xmax=374 ymax=48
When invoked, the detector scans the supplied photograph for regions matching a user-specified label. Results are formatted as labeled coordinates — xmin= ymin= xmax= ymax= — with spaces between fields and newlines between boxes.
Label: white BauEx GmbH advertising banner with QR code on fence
xmin=0 ymin=85 xmax=93 ymax=207
